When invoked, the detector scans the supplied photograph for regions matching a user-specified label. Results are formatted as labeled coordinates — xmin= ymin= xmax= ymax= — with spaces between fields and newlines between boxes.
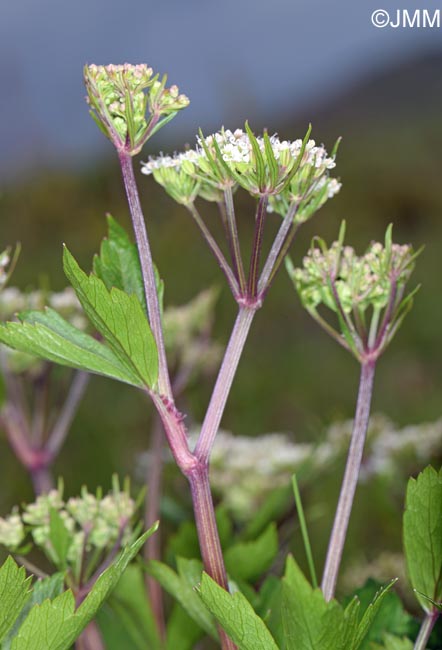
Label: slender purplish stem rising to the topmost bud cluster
xmin=118 ymin=150 xmax=172 ymax=399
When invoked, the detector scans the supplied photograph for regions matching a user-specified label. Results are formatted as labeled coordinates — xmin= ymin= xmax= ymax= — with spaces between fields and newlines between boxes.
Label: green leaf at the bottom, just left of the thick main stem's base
xmin=146 ymin=558 xmax=218 ymax=639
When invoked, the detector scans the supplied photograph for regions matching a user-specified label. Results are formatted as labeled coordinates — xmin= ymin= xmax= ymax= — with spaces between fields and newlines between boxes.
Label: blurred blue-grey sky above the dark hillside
xmin=0 ymin=0 xmax=442 ymax=180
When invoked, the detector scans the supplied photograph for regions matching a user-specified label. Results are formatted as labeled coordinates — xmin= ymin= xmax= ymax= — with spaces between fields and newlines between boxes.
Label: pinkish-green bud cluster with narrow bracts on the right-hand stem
xmin=286 ymin=224 xmax=420 ymax=359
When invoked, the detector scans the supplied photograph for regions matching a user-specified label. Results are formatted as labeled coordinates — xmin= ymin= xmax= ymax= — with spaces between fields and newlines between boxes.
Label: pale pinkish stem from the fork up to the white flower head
xmin=195 ymin=306 xmax=256 ymax=464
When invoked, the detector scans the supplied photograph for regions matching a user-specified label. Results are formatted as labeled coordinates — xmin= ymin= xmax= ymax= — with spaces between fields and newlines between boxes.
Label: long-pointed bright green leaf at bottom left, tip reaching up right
xmin=11 ymin=525 xmax=157 ymax=650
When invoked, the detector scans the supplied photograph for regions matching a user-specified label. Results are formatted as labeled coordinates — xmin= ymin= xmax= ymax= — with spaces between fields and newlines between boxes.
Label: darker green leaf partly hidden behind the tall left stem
xmin=93 ymin=214 xmax=147 ymax=311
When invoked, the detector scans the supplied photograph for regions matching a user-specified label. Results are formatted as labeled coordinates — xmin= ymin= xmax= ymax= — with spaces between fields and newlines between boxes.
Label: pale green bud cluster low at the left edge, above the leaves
xmin=0 ymin=482 xmax=136 ymax=573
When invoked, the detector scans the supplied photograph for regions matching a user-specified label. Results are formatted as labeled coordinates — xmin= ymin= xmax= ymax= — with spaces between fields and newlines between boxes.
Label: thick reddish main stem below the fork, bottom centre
xmin=187 ymin=463 xmax=240 ymax=650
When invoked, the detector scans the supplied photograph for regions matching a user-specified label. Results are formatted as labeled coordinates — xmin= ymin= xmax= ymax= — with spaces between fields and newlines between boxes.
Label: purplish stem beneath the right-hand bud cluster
xmin=321 ymin=360 xmax=375 ymax=601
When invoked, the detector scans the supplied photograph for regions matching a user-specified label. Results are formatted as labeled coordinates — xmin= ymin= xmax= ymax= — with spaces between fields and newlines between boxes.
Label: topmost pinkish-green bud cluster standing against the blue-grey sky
xmin=84 ymin=63 xmax=189 ymax=155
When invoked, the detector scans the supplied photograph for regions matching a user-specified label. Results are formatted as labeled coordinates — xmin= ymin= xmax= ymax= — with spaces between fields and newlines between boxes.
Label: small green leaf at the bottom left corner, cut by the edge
xmin=0 ymin=556 xmax=31 ymax=641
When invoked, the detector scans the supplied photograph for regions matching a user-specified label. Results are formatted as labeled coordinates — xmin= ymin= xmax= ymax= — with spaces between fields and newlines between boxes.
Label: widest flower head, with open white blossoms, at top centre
xmin=141 ymin=124 xmax=340 ymax=221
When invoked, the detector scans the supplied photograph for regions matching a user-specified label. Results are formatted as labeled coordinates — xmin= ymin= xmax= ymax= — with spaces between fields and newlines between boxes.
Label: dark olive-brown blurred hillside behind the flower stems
xmin=0 ymin=56 xmax=442 ymax=502
